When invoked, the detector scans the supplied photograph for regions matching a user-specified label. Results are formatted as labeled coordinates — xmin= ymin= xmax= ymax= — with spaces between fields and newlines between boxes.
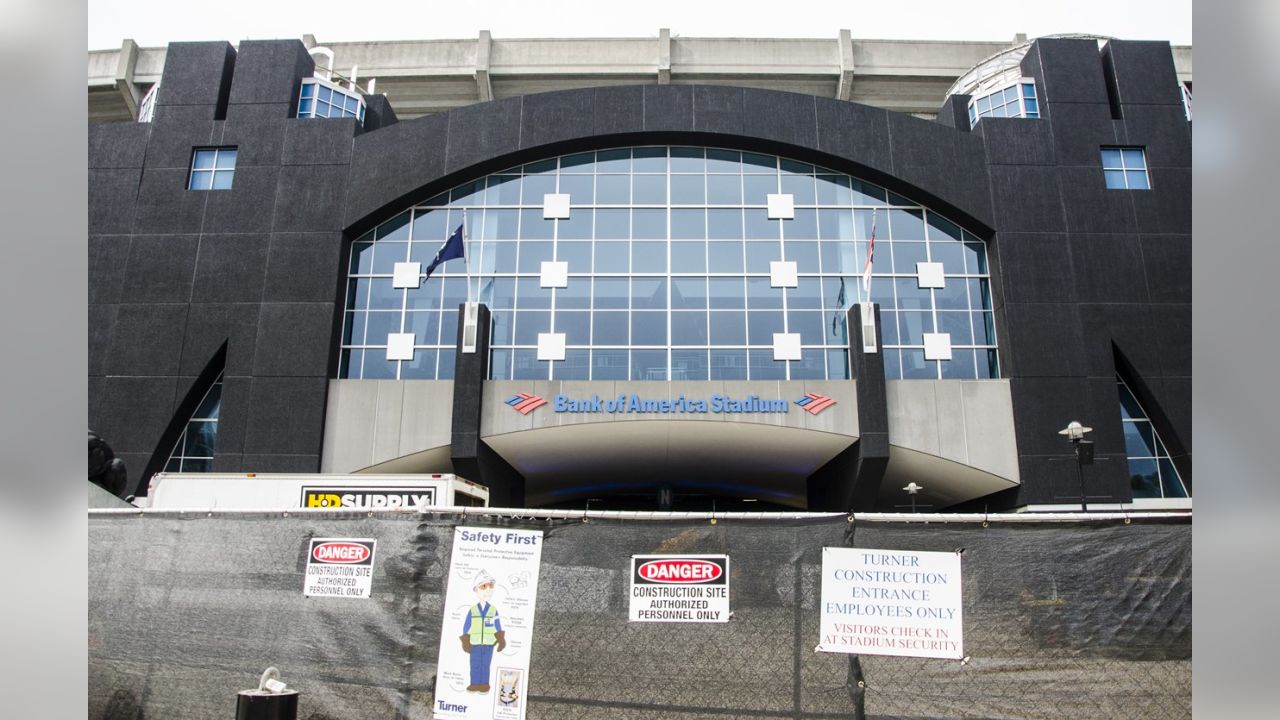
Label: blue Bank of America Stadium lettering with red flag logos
xmin=506 ymin=392 xmax=836 ymax=415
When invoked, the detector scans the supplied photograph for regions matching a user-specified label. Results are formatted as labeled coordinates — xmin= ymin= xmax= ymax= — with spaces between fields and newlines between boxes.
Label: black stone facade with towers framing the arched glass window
xmin=88 ymin=38 xmax=1192 ymax=510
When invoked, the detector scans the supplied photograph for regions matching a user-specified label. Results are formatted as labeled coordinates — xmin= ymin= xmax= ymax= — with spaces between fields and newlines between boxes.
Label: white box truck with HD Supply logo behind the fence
xmin=142 ymin=473 xmax=489 ymax=511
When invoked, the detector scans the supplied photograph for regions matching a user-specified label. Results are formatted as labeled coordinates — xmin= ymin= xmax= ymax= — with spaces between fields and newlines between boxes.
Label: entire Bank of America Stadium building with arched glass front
xmin=88 ymin=32 xmax=1192 ymax=511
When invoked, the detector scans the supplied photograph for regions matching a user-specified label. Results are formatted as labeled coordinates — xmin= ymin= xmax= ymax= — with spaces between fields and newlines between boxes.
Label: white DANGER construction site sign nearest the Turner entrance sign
xmin=630 ymin=555 xmax=730 ymax=623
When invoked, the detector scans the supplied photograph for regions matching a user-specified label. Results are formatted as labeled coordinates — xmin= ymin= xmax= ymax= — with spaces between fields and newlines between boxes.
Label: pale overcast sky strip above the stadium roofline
xmin=88 ymin=0 xmax=1192 ymax=50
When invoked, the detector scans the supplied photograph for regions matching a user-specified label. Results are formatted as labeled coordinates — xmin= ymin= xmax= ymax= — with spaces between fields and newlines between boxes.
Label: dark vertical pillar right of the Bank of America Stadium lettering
xmin=840 ymin=305 xmax=888 ymax=511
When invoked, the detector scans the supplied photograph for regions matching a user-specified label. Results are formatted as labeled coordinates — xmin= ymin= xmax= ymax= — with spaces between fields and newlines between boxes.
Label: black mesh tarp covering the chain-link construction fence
xmin=88 ymin=512 xmax=1190 ymax=720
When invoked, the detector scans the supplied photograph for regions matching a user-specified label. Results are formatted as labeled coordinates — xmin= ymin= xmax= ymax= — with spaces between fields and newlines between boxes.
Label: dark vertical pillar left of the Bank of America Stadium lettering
xmin=451 ymin=304 xmax=525 ymax=507
